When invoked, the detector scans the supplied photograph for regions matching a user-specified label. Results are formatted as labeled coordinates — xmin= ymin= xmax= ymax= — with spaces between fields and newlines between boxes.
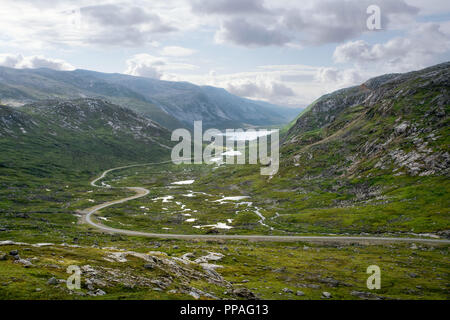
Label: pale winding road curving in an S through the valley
xmin=82 ymin=161 xmax=450 ymax=244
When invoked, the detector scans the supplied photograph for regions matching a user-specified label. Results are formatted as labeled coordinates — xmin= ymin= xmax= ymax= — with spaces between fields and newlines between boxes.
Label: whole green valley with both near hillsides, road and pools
xmin=0 ymin=63 xmax=450 ymax=300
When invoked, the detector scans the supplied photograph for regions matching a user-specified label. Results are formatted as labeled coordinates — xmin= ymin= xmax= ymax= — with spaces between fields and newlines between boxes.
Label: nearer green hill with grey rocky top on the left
xmin=0 ymin=99 xmax=170 ymax=177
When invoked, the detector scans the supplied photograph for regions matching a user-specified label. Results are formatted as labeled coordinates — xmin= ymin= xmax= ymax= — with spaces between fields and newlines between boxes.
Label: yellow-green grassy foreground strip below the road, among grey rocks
xmin=0 ymin=236 xmax=449 ymax=299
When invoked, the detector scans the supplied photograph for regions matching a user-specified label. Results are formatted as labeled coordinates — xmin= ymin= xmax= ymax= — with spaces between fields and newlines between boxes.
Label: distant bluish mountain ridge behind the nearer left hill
xmin=0 ymin=67 xmax=299 ymax=129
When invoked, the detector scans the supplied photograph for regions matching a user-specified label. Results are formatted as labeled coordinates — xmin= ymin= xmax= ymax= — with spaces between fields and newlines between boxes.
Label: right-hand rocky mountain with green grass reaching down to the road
xmin=199 ymin=63 xmax=450 ymax=236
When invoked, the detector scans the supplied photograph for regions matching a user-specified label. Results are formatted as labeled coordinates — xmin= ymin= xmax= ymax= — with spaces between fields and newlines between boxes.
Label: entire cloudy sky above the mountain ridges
xmin=0 ymin=0 xmax=450 ymax=106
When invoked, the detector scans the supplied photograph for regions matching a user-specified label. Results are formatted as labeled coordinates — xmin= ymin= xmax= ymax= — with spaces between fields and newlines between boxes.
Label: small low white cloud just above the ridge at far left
xmin=0 ymin=53 xmax=75 ymax=71
